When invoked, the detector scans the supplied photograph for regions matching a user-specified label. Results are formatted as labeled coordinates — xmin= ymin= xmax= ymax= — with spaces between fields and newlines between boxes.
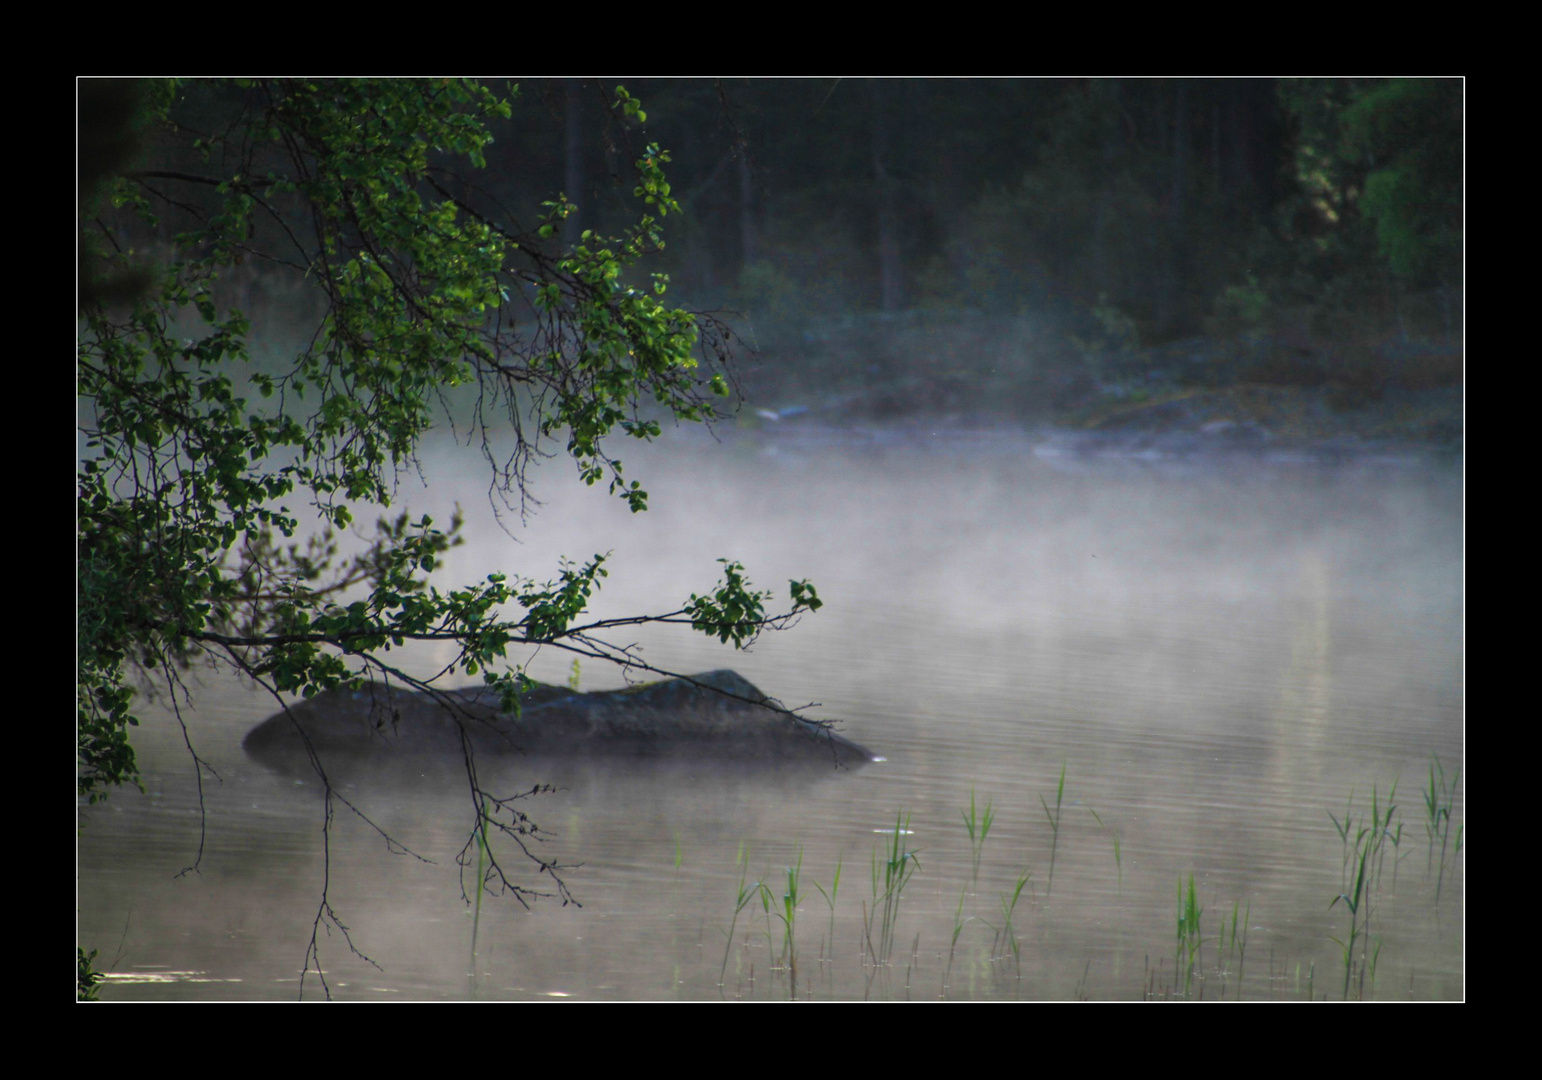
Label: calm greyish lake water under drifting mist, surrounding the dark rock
xmin=79 ymin=432 xmax=1465 ymax=1000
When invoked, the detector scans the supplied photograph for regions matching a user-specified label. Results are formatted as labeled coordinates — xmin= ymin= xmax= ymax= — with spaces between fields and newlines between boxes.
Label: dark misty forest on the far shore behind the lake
xmin=105 ymin=79 xmax=1465 ymax=412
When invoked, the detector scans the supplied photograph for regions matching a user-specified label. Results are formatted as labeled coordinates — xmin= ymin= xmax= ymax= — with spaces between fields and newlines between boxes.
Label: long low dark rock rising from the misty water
xmin=242 ymin=670 xmax=876 ymax=767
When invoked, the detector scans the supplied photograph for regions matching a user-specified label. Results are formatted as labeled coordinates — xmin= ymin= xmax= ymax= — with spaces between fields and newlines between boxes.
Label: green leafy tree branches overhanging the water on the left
xmin=77 ymin=79 xmax=819 ymax=802
